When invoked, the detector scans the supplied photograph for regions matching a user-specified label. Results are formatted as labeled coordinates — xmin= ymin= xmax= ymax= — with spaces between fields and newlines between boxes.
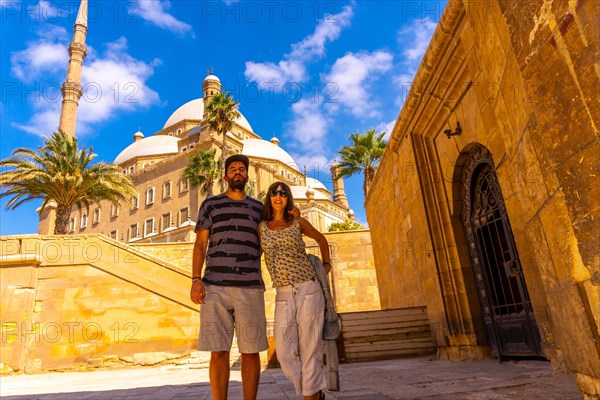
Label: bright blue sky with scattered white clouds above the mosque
xmin=0 ymin=0 xmax=446 ymax=235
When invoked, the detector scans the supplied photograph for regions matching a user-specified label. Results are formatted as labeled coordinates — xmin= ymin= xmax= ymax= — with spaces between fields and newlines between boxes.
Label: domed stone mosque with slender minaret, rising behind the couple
xmin=38 ymin=2 xmax=354 ymax=243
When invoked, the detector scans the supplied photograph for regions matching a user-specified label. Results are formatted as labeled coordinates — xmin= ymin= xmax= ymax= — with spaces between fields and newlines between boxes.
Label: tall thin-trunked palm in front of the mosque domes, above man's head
xmin=206 ymin=93 xmax=241 ymax=192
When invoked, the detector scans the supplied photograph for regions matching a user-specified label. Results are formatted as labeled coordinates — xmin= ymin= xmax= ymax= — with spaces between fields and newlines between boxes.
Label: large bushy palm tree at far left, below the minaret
xmin=0 ymin=131 xmax=137 ymax=235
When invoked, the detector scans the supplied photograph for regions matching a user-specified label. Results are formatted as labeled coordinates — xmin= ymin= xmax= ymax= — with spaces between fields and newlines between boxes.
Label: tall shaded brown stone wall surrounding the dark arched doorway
xmin=366 ymin=0 xmax=600 ymax=398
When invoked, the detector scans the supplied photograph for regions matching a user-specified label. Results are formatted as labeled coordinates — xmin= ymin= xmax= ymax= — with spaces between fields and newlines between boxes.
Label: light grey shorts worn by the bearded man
xmin=198 ymin=285 xmax=269 ymax=353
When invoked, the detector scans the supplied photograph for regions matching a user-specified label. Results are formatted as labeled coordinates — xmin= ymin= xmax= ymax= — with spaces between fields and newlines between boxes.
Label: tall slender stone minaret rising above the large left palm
xmin=58 ymin=0 xmax=88 ymax=137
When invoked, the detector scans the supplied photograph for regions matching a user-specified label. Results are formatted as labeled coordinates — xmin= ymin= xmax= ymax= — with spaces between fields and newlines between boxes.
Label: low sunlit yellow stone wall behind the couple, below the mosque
xmin=0 ymin=231 xmax=380 ymax=373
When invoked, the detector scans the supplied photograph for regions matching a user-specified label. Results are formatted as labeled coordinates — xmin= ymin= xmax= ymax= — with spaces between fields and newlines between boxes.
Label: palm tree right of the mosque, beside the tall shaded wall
xmin=335 ymin=129 xmax=387 ymax=196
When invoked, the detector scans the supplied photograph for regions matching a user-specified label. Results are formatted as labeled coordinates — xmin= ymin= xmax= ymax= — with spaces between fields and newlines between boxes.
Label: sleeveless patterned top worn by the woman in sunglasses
xmin=258 ymin=219 xmax=317 ymax=288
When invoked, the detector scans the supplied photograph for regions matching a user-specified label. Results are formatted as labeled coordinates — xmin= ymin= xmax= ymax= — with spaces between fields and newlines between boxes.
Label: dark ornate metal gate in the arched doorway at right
xmin=462 ymin=145 xmax=541 ymax=358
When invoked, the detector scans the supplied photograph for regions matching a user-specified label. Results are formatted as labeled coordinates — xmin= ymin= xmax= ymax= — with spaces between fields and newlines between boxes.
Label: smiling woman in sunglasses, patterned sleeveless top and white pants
xmin=258 ymin=182 xmax=331 ymax=400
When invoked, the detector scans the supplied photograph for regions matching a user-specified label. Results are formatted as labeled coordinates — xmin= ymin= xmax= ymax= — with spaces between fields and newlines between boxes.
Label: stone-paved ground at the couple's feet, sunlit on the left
xmin=0 ymin=357 xmax=582 ymax=400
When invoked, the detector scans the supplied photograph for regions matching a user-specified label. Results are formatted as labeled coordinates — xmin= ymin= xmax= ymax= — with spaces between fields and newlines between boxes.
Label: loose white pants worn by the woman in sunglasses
xmin=275 ymin=281 xmax=326 ymax=396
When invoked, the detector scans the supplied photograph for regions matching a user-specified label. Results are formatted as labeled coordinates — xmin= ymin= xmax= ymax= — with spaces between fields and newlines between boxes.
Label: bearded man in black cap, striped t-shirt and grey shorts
xmin=190 ymin=154 xmax=300 ymax=400
